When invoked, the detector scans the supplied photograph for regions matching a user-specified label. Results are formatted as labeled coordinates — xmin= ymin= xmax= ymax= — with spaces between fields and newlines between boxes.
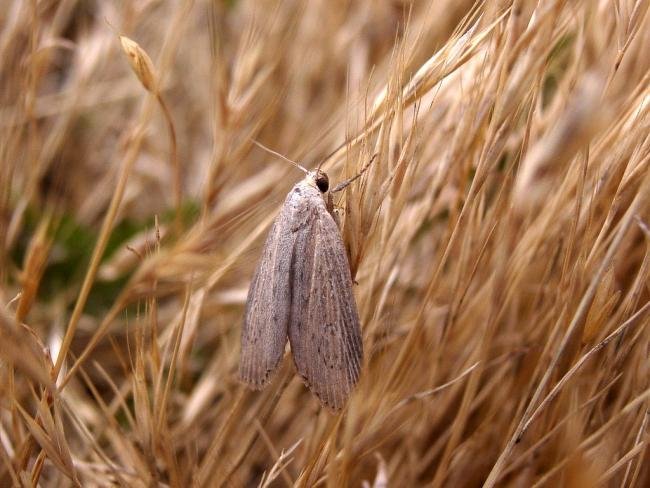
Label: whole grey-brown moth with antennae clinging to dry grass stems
xmin=239 ymin=144 xmax=372 ymax=411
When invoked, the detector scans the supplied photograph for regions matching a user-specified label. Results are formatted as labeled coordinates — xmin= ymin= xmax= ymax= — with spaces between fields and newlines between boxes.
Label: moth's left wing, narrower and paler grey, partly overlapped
xmin=239 ymin=205 xmax=293 ymax=389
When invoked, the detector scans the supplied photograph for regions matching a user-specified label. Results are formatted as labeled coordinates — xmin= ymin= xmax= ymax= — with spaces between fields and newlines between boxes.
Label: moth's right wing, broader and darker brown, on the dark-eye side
xmin=289 ymin=204 xmax=363 ymax=410
